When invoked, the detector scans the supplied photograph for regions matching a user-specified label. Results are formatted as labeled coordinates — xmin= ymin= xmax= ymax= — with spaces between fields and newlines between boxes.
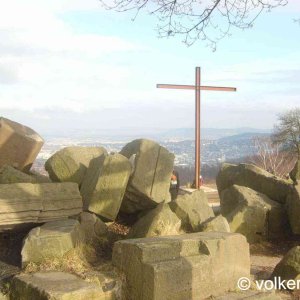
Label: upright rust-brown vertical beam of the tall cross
xmin=195 ymin=67 xmax=201 ymax=189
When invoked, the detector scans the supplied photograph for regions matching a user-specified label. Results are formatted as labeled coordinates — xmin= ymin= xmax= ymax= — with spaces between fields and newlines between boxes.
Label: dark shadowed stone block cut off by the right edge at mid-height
xmin=286 ymin=183 xmax=300 ymax=234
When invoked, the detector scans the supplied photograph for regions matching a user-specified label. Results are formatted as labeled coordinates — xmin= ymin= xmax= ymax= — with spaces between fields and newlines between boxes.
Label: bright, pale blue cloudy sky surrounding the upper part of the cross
xmin=0 ymin=0 xmax=300 ymax=134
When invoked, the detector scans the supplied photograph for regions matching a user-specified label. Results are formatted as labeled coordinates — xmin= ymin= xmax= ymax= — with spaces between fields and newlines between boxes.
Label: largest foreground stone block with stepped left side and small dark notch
xmin=113 ymin=232 xmax=250 ymax=300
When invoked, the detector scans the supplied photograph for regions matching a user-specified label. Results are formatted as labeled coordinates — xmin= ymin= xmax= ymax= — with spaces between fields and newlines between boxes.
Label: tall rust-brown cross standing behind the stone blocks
xmin=156 ymin=67 xmax=236 ymax=189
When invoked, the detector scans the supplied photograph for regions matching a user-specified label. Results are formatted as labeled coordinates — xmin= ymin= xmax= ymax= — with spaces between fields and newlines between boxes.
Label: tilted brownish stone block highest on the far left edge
xmin=0 ymin=117 xmax=44 ymax=171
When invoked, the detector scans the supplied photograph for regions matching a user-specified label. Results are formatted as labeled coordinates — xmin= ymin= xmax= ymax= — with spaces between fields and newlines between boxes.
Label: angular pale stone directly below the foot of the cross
xmin=169 ymin=190 xmax=215 ymax=232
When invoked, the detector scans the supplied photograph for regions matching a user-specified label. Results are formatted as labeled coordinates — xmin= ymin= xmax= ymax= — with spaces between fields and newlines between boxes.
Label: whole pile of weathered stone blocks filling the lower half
xmin=0 ymin=118 xmax=300 ymax=300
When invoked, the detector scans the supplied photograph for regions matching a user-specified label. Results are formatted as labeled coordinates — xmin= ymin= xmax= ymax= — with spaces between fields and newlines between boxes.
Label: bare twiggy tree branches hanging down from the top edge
xmin=100 ymin=0 xmax=288 ymax=49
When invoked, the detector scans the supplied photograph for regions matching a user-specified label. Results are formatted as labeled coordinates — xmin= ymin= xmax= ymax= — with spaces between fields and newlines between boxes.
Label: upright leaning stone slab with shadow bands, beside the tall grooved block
xmin=80 ymin=154 xmax=132 ymax=220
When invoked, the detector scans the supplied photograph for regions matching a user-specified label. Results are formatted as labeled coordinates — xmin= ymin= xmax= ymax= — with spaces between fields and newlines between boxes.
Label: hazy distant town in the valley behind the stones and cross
xmin=34 ymin=127 xmax=268 ymax=181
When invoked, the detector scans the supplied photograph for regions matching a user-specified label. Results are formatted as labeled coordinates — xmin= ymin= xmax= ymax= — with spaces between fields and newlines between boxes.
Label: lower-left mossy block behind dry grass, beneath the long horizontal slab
xmin=21 ymin=219 xmax=83 ymax=266
